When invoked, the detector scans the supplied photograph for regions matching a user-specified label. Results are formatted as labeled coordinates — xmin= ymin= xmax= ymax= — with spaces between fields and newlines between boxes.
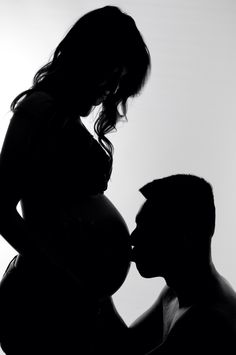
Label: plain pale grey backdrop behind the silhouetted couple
xmin=0 ymin=0 xmax=236 ymax=350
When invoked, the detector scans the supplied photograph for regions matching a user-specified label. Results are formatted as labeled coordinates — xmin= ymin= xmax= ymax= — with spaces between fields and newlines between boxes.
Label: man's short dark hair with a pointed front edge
xmin=140 ymin=174 xmax=215 ymax=238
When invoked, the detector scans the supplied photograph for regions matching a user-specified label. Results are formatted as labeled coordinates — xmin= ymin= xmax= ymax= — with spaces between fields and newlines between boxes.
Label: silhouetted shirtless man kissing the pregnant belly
xmin=129 ymin=174 xmax=236 ymax=355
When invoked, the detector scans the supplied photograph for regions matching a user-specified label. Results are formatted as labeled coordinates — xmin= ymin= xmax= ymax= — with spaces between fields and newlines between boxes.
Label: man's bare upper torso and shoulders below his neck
xmin=157 ymin=275 xmax=236 ymax=354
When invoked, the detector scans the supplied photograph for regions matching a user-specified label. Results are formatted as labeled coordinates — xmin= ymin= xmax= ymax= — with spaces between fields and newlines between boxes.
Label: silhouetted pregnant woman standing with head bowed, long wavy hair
xmin=0 ymin=6 xmax=150 ymax=355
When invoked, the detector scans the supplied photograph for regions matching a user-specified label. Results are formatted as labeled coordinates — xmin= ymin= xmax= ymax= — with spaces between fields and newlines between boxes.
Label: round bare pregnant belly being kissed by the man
xmin=18 ymin=194 xmax=131 ymax=298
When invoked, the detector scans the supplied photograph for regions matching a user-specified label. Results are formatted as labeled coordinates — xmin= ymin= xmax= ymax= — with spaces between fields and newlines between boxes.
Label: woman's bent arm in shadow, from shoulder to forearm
xmin=0 ymin=100 xmax=77 ymax=280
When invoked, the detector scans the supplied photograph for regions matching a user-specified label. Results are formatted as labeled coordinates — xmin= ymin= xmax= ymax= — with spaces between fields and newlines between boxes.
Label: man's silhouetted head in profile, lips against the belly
xmin=132 ymin=174 xmax=215 ymax=277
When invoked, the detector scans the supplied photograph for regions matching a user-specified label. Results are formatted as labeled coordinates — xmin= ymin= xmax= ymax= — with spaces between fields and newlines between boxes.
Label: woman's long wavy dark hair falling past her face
xmin=11 ymin=6 xmax=151 ymax=169
